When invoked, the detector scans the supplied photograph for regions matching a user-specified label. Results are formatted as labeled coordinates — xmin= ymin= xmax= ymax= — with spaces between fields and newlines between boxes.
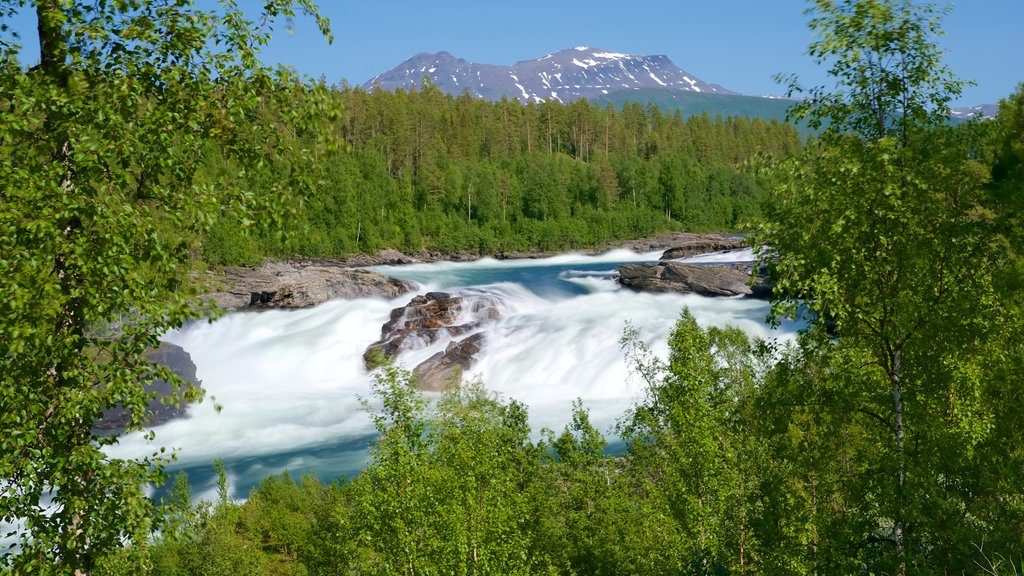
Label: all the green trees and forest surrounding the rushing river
xmin=0 ymin=0 xmax=1024 ymax=576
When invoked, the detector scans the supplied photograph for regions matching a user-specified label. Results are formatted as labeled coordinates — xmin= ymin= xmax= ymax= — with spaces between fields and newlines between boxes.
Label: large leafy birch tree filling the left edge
xmin=0 ymin=0 xmax=328 ymax=574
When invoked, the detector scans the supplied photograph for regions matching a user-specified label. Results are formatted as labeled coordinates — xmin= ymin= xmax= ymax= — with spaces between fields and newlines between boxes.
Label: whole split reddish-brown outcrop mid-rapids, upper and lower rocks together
xmin=362 ymin=292 xmax=501 ymax=392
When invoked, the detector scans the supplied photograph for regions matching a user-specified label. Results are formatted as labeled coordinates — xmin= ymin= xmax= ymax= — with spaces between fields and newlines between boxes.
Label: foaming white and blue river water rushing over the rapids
xmin=103 ymin=251 xmax=795 ymax=496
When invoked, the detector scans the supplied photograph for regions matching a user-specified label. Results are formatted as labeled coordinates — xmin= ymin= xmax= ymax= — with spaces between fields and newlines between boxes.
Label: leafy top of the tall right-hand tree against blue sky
xmin=780 ymin=0 xmax=965 ymax=146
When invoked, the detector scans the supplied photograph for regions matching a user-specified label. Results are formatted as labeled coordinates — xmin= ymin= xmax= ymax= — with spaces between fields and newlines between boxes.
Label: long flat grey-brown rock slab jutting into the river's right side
xmin=618 ymin=261 xmax=753 ymax=296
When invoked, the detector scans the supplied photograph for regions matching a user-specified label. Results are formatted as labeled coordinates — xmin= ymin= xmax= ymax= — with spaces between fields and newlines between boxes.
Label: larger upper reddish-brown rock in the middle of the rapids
xmin=362 ymin=292 xmax=501 ymax=369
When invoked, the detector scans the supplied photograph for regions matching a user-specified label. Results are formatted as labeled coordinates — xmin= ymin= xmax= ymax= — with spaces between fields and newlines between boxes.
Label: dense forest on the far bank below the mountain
xmin=202 ymin=81 xmax=801 ymax=264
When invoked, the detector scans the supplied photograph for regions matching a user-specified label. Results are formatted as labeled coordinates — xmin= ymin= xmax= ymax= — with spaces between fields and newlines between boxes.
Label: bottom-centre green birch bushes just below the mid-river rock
xmin=338 ymin=368 xmax=537 ymax=574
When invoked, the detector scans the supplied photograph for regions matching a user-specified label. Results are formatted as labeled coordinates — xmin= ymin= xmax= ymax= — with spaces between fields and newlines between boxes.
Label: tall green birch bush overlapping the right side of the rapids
xmin=621 ymin=311 xmax=780 ymax=574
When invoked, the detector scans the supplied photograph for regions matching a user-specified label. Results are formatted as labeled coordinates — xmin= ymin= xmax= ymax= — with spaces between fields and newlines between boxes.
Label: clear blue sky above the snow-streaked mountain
xmin=4 ymin=0 xmax=1024 ymax=106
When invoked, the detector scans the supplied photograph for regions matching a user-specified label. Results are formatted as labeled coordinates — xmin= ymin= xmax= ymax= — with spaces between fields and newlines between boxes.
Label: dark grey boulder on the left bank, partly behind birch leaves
xmin=92 ymin=342 xmax=201 ymax=434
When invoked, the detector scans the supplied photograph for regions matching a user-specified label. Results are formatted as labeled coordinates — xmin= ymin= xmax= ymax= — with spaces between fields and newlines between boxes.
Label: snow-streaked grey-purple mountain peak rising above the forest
xmin=362 ymin=46 xmax=735 ymax=102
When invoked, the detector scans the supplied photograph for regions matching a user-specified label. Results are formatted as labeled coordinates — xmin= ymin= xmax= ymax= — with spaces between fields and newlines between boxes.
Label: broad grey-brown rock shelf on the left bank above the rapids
xmin=208 ymin=261 xmax=416 ymax=310
